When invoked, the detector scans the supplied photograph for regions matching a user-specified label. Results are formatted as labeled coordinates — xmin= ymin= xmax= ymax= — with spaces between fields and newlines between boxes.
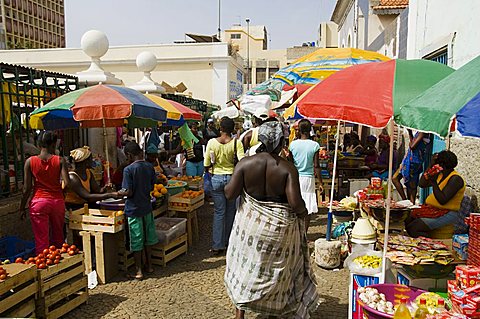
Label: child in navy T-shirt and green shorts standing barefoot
xmin=119 ymin=142 xmax=158 ymax=280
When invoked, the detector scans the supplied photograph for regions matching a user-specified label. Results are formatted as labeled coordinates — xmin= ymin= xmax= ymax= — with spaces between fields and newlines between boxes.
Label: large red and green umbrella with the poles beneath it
xmin=294 ymin=60 xmax=453 ymax=282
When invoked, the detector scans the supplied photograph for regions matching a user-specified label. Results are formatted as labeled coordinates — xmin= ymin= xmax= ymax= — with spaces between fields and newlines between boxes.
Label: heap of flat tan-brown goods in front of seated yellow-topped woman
xmin=378 ymin=235 xmax=454 ymax=266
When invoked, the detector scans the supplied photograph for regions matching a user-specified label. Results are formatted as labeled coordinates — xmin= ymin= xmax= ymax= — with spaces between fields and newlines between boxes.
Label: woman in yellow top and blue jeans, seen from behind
xmin=203 ymin=117 xmax=244 ymax=255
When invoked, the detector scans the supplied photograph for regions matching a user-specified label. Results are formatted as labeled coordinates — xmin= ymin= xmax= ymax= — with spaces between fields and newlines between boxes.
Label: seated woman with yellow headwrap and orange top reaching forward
xmin=65 ymin=146 xmax=118 ymax=209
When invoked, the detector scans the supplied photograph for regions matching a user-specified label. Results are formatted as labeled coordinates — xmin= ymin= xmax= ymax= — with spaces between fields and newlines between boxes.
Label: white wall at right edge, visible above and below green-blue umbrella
xmin=407 ymin=0 xmax=480 ymax=194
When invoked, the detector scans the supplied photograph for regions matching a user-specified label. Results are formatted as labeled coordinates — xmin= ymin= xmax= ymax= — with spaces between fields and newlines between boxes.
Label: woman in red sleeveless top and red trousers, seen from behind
xmin=20 ymin=131 xmax=69 ymax=254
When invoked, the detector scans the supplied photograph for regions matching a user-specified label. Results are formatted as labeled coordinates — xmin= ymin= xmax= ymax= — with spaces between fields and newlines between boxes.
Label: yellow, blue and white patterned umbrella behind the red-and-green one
xmin=247 ymin=48 xmax=390 ymax=101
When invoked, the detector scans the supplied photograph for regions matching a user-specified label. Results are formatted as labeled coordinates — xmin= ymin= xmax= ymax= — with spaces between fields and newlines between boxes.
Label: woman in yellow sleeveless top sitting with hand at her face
xmin=406 ymin=151 xmax=466 ymax=237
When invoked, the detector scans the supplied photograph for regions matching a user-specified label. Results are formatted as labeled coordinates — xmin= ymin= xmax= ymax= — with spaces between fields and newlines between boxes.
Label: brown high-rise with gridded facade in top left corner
xmin=0 ymin=0 xmax=65 ymax=49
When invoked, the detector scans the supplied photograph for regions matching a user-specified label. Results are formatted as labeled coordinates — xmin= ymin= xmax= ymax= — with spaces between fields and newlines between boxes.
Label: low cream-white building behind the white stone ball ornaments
xmin=0 ymin=42 xmax=244 ymax=107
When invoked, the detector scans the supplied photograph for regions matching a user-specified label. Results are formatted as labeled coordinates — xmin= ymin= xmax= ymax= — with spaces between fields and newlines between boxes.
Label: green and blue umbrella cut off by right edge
xmin=395 ymin=56 xmax=480 ymax=138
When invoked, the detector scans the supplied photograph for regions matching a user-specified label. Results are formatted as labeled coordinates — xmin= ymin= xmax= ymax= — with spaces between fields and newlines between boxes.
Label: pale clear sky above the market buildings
xmin=65 ymin=0 xmax=336 ymax=49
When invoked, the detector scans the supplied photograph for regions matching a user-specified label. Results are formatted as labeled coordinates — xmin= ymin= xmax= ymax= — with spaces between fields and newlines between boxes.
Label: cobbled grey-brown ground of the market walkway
xmin=67 ymin=204 xmax=348 ymax=319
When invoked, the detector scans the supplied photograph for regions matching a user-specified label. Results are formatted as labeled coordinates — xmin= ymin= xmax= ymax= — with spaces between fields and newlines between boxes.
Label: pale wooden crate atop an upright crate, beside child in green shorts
xmin=69 ymin=205 xmax=125 ymax=233
